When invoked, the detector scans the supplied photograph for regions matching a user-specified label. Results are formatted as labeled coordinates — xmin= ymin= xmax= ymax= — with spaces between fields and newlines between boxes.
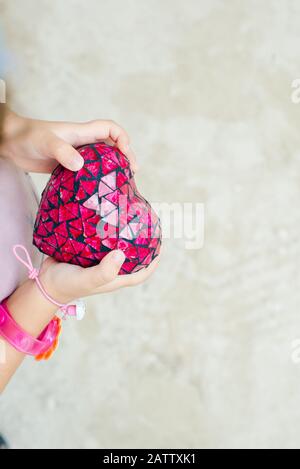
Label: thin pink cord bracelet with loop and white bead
xmin=13 ymin=244 xmax=85 ymax=320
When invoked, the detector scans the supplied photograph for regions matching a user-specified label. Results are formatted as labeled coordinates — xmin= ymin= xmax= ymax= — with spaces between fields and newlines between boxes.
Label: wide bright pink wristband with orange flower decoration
xmin=0 ymin=300 xmax=61 ymax=360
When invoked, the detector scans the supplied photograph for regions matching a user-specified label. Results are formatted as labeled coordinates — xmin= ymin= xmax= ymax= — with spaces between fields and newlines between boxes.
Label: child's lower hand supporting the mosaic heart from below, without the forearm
xmin=40 ymin=250 xmax=160 ymax=303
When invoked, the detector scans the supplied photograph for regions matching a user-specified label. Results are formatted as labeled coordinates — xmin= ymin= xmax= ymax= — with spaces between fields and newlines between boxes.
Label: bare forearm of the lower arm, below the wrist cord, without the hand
xmin=0 ymin=280 xmax=57 ymax=393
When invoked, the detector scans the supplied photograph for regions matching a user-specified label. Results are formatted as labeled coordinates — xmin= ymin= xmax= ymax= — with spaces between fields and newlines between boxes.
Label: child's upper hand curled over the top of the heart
xmin=0 ymin=111 xmax=137 ymax=173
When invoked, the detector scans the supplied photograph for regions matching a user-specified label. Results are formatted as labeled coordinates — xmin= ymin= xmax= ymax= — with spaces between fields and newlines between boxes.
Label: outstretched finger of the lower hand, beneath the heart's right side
xmin=94 ymin=252 xmax=160 ymax=294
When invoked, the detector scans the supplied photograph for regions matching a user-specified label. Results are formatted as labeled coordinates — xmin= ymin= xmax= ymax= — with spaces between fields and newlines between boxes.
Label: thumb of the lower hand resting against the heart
xmin=81 ymin=250 xmax=125 ymax=291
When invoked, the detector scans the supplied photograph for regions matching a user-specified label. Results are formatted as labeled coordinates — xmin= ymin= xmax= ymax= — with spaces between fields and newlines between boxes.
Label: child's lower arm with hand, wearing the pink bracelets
xmin=0 ymin=241 xmax=159 ymax=393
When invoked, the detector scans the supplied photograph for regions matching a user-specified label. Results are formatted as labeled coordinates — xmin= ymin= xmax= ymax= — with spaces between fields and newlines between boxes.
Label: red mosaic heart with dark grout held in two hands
xmin=33 ymin=143 xmax=161 ymax=275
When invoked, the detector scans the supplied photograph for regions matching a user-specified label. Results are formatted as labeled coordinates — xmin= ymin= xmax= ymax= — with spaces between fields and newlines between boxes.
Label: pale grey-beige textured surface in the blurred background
xmin=0 ymin=0 xmax=300 ymax=448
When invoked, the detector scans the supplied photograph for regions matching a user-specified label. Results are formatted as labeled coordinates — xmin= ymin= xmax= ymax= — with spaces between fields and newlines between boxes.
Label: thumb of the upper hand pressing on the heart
xmin=47 ymin=135 xmax=84 ymax=171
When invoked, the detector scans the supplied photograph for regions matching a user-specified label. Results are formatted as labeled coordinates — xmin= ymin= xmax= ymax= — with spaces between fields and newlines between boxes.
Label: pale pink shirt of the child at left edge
xmin=0 ymin=157 xmax=42 ymax=301
